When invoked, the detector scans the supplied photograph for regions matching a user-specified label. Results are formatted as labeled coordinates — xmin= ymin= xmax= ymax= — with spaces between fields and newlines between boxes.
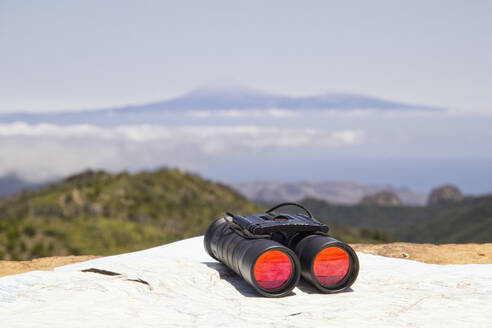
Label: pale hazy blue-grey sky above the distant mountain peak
xmin=0 ymin=0 xmax=492 ymax=112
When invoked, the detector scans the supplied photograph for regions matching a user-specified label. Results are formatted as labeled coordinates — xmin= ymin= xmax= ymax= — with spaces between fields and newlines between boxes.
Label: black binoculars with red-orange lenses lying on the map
xmin=204 ymin=203 xmax=359 ymax=297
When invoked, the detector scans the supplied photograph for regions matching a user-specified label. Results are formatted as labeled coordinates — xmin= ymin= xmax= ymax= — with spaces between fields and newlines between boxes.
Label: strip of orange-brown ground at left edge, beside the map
xmin=0 ymin=255 xmax=99 ymax=277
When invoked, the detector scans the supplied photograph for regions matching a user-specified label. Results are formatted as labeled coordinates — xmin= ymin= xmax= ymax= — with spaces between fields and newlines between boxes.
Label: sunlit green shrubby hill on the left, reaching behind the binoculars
xmin=0 ymin=169 xmax=386 ymax=260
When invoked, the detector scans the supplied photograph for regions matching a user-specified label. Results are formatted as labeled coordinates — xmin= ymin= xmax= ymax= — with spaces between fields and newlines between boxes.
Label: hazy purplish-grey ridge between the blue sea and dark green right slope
xmin=233 ymin=181 xmax=427 ymax=205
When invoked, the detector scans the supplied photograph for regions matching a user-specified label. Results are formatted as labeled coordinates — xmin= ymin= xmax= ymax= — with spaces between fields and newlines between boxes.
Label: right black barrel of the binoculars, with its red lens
xmin=294 ymin=234 xmax=359 ymax=293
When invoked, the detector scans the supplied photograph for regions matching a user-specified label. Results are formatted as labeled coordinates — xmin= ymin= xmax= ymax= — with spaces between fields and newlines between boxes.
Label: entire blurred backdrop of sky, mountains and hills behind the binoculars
xmin=0 ymin=0 xmax=492 ymax=259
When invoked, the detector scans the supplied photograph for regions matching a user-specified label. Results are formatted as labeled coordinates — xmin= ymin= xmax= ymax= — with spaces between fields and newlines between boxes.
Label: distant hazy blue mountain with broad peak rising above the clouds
xmin=0 ymin=87 xmax=441 ymax=124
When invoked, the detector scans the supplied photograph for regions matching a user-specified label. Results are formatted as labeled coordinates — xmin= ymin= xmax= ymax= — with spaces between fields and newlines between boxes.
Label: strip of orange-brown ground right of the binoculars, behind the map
xmin=352 ymin=243 xmax=492 ymax=264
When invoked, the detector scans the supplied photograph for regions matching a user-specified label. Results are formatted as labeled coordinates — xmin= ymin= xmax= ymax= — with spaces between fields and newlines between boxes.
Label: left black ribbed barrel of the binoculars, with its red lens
xmin=204 ymin=218 xmax=301 ymax=297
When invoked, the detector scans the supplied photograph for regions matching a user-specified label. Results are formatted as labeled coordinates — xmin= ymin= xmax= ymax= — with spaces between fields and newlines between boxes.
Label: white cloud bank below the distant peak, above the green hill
xmin=0 ymin=122 xmax=365 ymax=181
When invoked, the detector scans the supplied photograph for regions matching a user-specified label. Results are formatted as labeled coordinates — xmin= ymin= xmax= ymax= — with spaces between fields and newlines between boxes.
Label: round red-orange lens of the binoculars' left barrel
xmin=254 ymin=251 xmax=293 ymax=290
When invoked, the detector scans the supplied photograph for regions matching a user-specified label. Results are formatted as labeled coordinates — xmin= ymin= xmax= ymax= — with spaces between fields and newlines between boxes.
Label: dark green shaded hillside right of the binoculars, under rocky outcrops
xmin=302 ymin=195 xmax=492 ymax=243
